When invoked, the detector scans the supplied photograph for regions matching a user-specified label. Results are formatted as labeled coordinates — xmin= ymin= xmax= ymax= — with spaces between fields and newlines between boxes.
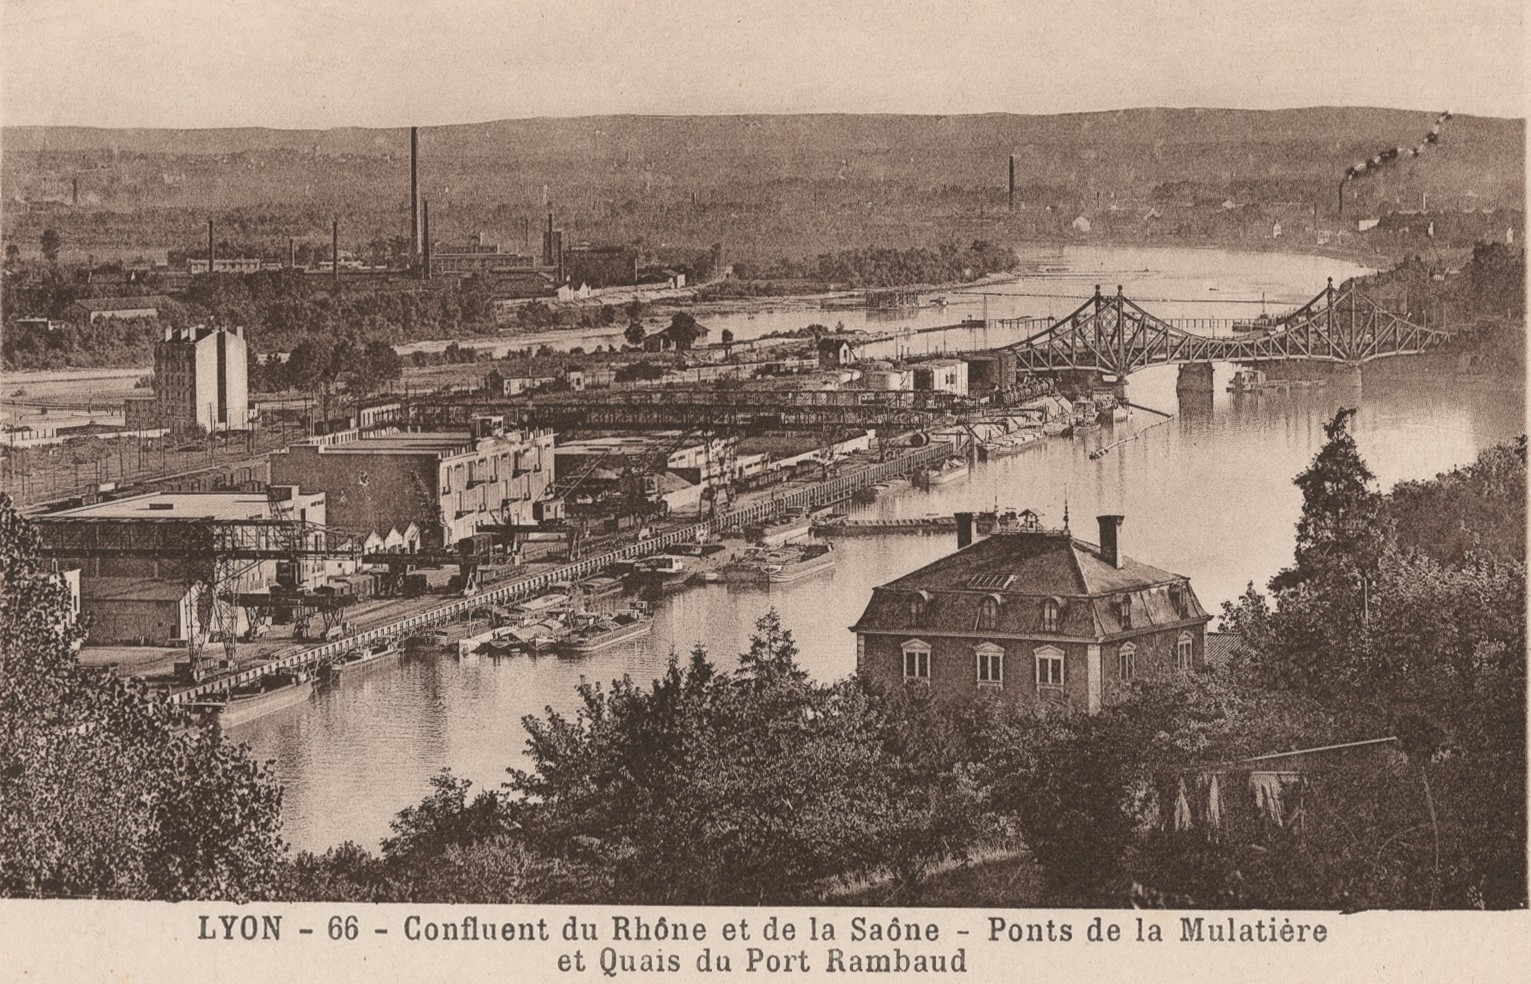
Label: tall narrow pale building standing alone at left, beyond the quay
xmin=155 ymin=326 xmax=250 ymax=433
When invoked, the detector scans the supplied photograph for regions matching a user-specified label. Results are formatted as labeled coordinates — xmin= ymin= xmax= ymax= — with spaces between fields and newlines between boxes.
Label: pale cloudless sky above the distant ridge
xmin=0 ymin=0 xmax=1526 ymax=129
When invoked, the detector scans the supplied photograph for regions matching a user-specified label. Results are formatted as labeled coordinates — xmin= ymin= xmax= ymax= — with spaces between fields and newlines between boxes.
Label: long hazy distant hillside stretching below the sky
xmin=0 ymin=107 xmax=1525 ymax=257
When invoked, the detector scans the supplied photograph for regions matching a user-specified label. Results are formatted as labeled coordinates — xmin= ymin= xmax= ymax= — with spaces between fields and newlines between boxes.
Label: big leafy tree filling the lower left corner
xmin=0 ymin=496 xmax=285 ymax=901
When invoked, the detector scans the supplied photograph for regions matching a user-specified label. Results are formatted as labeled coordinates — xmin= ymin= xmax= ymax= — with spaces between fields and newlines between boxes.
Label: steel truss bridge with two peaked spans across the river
xmin=1006 ymin=280 xmax=1451 ymax=376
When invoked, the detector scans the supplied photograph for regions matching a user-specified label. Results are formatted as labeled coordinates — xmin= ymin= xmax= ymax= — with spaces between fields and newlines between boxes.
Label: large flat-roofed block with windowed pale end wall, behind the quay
xmin=271 ymin=416 xmax=554 ymax=548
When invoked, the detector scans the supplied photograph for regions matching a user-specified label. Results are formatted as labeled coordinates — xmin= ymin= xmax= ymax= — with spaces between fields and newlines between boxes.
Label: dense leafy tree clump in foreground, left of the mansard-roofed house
xmin=508 ymin=614 xmax=926 ymax=904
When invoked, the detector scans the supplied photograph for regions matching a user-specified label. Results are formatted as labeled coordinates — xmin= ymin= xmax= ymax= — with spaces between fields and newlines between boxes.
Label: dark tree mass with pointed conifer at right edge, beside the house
xmin=1225 ymin=438 xmax=1526 ymax=907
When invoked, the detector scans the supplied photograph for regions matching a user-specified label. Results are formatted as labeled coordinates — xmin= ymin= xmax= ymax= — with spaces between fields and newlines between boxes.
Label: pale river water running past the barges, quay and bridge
xmin=231 ymin=249 xmax=1525 ymax=849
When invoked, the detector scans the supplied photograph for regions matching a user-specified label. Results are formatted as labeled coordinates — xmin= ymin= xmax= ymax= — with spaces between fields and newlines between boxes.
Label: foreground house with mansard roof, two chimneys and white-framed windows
xmin=851 ymin=513 xmax=1211 ymax=713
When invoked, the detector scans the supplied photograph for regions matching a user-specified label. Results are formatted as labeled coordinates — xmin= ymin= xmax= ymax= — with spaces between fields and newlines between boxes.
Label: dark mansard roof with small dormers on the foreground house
xmin=851 ymin=531 xmax=1209 ymax=640
